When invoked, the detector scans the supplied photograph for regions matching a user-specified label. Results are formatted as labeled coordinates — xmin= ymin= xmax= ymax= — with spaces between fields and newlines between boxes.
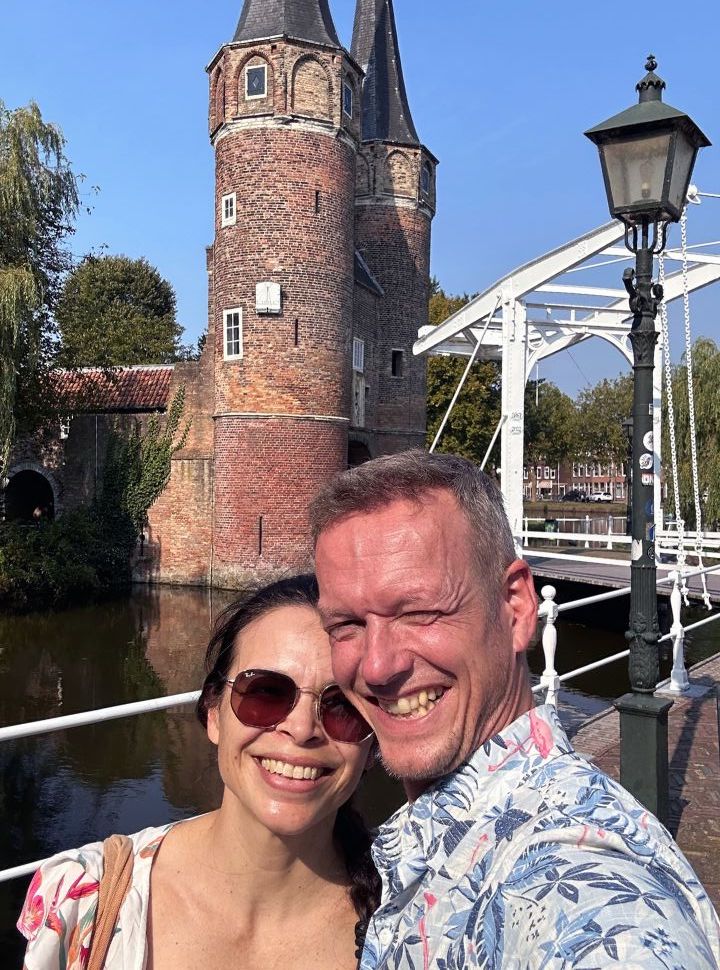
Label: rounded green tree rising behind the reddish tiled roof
xmin=56 ymin=256 xmax=182 ymax=367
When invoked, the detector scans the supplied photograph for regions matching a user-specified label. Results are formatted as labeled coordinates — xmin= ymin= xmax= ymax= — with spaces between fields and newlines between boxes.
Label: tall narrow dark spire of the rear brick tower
xmin=351 ymin=0 xmax=420 ymax=145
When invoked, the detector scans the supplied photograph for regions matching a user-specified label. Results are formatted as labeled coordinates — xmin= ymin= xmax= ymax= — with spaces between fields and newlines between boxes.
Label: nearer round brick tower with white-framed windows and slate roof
xmin=208 ymin=0 xmax=361 ymax=586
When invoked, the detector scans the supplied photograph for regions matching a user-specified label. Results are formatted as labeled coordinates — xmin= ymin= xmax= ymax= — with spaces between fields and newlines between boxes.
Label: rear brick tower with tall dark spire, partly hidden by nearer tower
xmin=351 ymin=0 xmax=437 ymax=455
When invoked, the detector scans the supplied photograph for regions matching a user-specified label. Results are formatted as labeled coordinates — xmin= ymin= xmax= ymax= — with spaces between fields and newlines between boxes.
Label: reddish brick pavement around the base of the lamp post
xmin=573 ymin=654 xmax=720 ymax=912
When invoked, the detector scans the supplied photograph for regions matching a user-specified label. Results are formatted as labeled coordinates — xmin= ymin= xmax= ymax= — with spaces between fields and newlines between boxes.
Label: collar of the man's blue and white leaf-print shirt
xmin=373 ymin=704 xmax=572 ymax=898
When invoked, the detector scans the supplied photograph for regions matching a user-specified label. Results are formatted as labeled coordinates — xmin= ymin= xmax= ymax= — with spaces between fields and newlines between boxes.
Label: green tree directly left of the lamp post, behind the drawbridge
xmin=577 ymin=374 xmax=633 ymax=465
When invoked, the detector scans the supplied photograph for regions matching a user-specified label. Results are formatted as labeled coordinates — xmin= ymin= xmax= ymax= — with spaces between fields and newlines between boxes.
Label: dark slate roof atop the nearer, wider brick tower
xmin=233 ymin=0 xmax=340 ymax=47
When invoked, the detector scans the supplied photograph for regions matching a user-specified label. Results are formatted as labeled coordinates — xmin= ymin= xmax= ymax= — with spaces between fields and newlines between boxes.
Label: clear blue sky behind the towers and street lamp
xmin=0 ymin=0 xmax=720 ymax=393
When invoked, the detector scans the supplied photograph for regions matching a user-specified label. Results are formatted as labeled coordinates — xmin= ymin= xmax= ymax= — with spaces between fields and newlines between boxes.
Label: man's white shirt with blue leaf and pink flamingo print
xmin=361 ymin=705 xmax=720 ymax=970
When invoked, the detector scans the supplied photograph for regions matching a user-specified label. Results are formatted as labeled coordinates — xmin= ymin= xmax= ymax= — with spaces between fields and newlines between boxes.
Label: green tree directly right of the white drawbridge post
xmin=525 ymin=380 xmax=579 ymax=465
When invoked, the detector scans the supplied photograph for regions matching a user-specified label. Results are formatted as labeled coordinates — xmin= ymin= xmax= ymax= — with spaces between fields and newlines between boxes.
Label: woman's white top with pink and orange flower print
xmin=17 ymin=825 xmax=172 ymax=970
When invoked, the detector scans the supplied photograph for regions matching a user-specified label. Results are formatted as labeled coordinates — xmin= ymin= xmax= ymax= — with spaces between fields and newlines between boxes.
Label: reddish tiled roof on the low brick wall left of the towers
xmin=54 ymin=364 xmax=173 ymax=413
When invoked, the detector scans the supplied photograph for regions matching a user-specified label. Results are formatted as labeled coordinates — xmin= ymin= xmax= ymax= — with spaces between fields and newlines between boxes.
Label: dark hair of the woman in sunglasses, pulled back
xmin=196 ymin=575 xmax=380 ymax=962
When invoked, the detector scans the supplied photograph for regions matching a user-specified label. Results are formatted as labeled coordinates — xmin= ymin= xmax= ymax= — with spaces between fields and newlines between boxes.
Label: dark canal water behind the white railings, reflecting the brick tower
xmin=0 ymin=587 xmax=720 ymax=956
